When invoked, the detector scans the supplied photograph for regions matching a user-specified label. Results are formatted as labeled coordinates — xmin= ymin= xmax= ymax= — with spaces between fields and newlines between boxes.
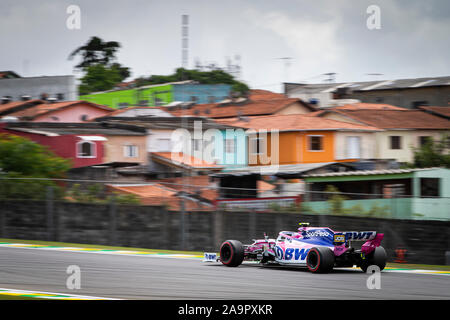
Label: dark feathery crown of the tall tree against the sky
xmin=69 ymin=37 xmax=120 ymax=69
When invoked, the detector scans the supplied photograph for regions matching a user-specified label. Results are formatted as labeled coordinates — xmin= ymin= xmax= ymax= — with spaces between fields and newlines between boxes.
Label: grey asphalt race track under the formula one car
xmin=0 ymin=248 xmax=450 ymax=300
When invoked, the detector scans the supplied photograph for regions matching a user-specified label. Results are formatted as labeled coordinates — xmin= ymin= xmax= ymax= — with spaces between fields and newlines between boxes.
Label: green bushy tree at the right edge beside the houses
xmin=407 ymin=134 xmax=450 ymax=168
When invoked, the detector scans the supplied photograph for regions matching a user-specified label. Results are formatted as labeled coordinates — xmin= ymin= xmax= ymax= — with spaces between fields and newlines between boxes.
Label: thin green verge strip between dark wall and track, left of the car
xmin=0 ymin=238 xmax=203 ymax=256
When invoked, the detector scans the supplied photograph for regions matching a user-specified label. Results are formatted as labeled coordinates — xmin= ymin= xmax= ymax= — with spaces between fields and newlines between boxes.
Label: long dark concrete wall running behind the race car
xmin=0 ymin=200 xmax=450 ymax=264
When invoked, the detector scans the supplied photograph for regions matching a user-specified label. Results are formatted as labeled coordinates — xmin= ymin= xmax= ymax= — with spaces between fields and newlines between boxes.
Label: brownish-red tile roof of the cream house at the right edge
xmin=322 ymin=110 xmax=450 ymax=129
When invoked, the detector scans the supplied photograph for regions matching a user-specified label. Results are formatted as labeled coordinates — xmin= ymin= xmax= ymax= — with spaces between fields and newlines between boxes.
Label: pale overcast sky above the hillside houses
xmin=0 ymin=0 xmax=450 ymax=91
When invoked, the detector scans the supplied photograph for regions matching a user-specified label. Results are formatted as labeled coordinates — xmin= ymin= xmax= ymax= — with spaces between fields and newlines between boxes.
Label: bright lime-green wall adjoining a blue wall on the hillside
xmin=79 ymin=84 xmax=173 ymax=109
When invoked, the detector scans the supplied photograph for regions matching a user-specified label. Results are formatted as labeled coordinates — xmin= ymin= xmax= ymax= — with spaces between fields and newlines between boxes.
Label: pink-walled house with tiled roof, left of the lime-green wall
xmin=8 ymin=100 xmax=114 ymax=122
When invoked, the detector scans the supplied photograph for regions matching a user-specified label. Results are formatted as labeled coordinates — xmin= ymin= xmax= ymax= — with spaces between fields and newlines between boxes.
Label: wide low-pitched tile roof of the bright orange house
xmin=215 ymin=114 xmax=378 ymax=132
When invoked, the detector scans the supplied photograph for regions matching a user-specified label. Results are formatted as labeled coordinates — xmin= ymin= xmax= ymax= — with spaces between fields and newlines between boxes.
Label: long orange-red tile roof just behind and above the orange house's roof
xmin=161 ymin=98 xmax=315 ymax=118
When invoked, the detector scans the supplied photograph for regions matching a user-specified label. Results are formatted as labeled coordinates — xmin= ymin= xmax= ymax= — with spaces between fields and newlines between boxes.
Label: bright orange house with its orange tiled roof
xmin=216 ymin=114 xmax=379 ymax=166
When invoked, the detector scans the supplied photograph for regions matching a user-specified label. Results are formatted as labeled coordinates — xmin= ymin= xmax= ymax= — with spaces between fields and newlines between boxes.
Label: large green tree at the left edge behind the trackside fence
xmin=0 ymin=134 xmax=71 ymax=199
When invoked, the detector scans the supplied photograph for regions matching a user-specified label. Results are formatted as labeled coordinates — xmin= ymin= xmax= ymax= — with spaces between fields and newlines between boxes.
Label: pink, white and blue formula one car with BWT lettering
xmin=217 ymin=223 xmax=386 ymax=273
